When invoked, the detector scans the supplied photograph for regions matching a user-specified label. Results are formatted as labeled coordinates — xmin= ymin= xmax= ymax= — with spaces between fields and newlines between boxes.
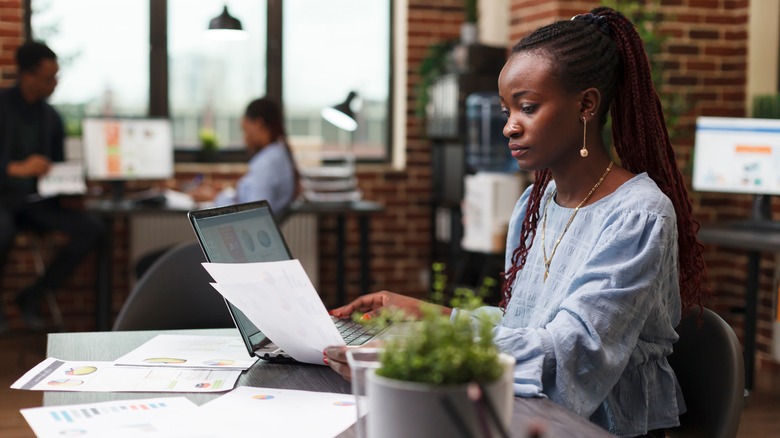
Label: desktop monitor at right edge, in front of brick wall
xmin=693 ymin=117 xmax=780 ymax=226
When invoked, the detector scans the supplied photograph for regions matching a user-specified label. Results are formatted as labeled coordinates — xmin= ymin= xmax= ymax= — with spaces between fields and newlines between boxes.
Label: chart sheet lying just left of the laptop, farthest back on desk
xmin=114 ymin=335 xmax=258 ymax=370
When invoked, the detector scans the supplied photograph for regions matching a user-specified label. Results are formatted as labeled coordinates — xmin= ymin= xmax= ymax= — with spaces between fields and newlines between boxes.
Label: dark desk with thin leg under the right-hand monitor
xmin=699 ymin=224 xmax=780 ymax=390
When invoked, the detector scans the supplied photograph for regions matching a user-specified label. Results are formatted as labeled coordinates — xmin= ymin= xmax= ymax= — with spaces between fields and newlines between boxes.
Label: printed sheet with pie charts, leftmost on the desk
xmin=11 ymin=357 xmax=241 ymax=392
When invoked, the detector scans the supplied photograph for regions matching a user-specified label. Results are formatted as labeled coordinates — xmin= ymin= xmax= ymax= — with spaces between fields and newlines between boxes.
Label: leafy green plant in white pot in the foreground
xmin=366 ymin=289 xmax=514 ymax=438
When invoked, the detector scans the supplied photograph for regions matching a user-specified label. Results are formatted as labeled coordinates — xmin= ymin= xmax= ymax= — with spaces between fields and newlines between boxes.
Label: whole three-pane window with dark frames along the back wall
xmin=25 ymin=0 xmax=397 ymax=160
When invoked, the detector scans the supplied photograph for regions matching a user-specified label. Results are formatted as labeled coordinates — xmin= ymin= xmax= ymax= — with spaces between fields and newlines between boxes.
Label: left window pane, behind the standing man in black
xmin=31 ymin=0 xmax=149 ymax=135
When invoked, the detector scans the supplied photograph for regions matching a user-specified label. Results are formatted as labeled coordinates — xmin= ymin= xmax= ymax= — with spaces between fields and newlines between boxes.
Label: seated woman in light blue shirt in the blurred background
xmin=191 ymin=97 xmax=299 ymax=215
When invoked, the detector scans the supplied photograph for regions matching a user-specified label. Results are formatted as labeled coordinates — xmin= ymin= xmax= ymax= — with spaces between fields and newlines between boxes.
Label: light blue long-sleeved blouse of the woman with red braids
xmin=495 ymin=174 xmax=684 ymax=436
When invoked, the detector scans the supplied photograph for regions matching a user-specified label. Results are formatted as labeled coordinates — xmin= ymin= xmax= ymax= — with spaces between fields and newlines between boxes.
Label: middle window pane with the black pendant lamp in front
xmin=168 ymin=0 xmax=266 ymax=149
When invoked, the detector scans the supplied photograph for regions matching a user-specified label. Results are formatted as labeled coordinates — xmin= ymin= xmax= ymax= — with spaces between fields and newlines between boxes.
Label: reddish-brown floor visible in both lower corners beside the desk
xmin=0 ymin=332 xmax=780 ymax=438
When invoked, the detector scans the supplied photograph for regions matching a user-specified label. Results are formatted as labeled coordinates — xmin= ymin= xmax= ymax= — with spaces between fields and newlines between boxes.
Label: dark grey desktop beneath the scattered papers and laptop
xmin=43 ymin=329 xmax=612 ymax=438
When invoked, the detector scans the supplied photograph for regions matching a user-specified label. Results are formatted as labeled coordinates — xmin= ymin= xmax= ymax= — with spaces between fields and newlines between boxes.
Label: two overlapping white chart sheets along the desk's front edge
xmin=21 ymin=387 xmax=356 ymax=438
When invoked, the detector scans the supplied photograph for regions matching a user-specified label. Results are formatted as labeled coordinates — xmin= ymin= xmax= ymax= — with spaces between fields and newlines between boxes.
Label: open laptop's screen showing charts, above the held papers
xmin=198 ymin=211 xmax=290 ymax=263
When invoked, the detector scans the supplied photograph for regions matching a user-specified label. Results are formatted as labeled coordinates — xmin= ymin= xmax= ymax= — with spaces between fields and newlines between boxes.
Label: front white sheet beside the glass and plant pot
xmin=199 ymin=386 xmax=357 ymax=438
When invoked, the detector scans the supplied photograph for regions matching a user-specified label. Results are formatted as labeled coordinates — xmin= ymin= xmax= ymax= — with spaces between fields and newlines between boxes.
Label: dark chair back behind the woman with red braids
xmin=667 ymin=307 xmax=745 ymax=438
